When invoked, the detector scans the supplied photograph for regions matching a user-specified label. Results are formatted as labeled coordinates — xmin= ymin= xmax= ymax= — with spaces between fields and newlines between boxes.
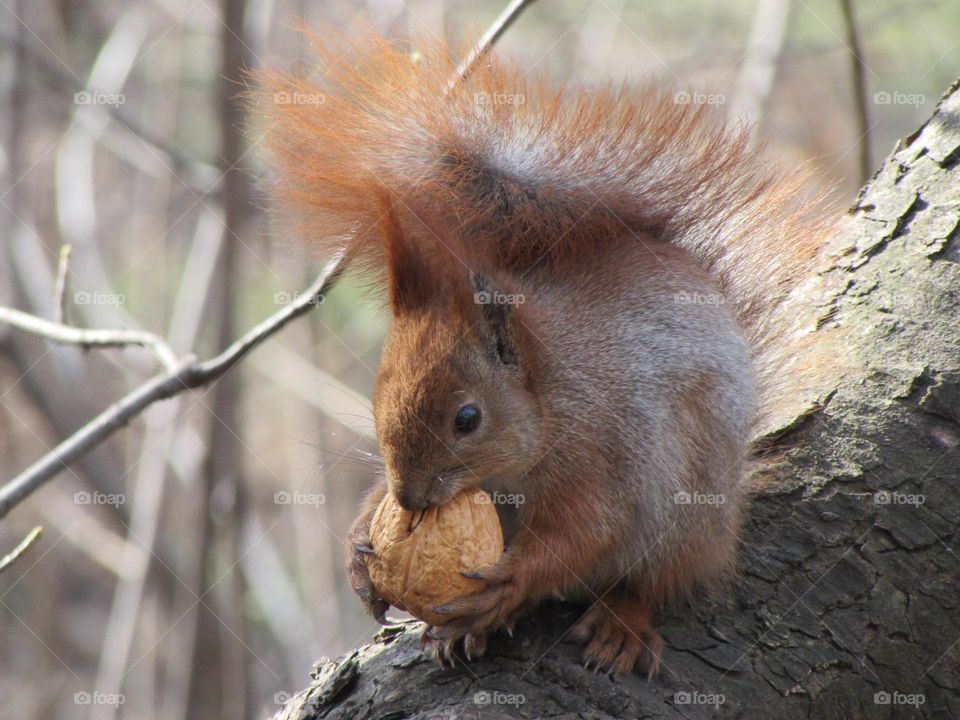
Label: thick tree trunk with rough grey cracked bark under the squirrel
xmin=276 ymin=82 xmax=960 ymax=720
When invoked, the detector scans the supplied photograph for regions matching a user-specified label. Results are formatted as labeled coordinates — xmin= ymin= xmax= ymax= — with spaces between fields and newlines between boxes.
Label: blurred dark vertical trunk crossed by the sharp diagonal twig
xmin=186 ymin=0 xmax=255 ymax=720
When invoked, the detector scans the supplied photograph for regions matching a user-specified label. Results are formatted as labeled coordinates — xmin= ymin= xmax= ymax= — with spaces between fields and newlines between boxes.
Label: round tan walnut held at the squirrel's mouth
xmin=365 ymin=488 xmax=503 ymax=625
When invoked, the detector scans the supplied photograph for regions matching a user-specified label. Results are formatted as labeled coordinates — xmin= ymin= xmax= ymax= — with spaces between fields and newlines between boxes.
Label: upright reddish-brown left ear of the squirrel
xmin=380 ymin=193 xmax=431 ymax=316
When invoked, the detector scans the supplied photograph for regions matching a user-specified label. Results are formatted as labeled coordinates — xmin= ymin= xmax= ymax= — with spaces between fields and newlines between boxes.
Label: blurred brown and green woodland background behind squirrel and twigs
xmin=0 ymin=0 xmax=960 ymax=720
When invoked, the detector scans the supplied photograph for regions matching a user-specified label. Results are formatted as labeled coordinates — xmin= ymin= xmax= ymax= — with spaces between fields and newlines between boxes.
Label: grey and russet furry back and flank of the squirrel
xmin=502 ymin=241 xmax=757 ymax=603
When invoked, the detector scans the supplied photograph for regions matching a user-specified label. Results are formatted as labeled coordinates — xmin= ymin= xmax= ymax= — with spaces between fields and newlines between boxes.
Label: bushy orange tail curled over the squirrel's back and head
xmin=257 ymin=32 xmax=826 ymax=420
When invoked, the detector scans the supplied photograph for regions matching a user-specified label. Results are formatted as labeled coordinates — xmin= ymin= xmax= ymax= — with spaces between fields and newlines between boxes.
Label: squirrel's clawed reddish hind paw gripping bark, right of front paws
xmin=570 ymin=598 xmax=663 ymax=680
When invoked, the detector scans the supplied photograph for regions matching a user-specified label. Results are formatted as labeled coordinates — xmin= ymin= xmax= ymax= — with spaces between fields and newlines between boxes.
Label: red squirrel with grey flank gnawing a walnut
xmin=258 ymin=32 xmax=826 ymax=677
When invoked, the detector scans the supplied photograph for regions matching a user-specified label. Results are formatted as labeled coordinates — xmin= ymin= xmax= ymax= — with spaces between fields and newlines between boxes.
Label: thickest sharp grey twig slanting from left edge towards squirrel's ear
xmin=0 ymin=252 xmax=346 ymax=518
